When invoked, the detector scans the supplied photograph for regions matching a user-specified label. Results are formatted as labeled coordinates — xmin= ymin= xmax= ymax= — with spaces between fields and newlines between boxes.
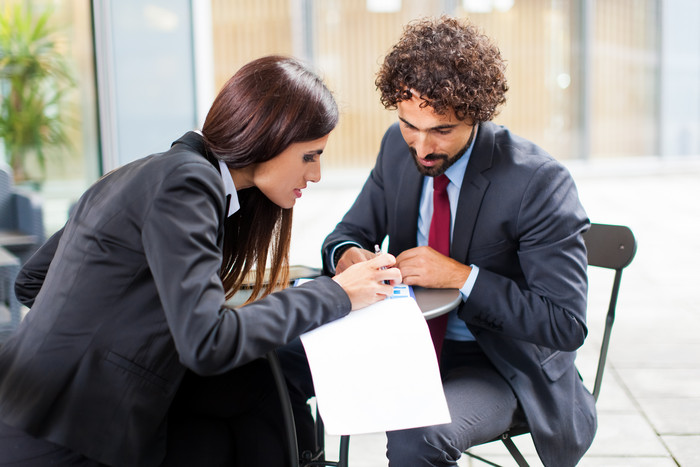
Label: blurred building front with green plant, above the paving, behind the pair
xmin=0 ymin=0 xmax=700 ymax=238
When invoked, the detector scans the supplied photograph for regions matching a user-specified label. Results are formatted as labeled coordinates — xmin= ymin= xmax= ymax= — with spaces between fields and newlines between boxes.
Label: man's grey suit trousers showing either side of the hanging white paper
xmin=277 ymin=339 xmax=524 ymax=467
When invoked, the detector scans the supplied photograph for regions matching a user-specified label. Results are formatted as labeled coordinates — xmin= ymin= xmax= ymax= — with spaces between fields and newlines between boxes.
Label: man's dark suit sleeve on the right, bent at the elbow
xmin=459 ymin=161 xmax=589 ymax=351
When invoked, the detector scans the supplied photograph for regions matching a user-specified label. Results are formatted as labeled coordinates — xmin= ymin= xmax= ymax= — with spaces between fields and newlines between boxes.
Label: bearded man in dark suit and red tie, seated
xmin=282 ymin=17 xmax=596 ymax=467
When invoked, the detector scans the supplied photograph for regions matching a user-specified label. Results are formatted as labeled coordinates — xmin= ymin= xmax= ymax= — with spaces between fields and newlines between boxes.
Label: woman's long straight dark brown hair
xmin=202 ymin=56 xmax=338 ymax=301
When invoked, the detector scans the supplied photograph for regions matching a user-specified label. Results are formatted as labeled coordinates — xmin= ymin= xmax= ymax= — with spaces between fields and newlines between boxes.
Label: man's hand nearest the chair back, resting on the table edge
xmin=396 ymin=246 xmax=472 ymax=289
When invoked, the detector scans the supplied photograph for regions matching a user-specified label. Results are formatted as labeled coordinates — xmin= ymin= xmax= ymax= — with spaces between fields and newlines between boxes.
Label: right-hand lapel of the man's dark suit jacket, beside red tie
xmin=450 ymin=122 xmax=494 ymax=264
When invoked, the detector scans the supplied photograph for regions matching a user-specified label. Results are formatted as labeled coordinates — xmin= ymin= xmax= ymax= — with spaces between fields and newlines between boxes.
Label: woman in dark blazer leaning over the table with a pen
xmin=0 ymin=57 xmax=400 ymax=466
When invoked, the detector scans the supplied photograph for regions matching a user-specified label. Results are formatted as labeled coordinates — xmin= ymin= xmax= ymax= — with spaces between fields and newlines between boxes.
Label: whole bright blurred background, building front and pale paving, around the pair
xmin=0 ymin=0 xmax=700 ymax=467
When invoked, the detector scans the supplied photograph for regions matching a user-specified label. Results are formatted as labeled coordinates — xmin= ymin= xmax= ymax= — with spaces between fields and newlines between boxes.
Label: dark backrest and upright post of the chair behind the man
xmin=583 ymin=224 xmax=637 ymax=400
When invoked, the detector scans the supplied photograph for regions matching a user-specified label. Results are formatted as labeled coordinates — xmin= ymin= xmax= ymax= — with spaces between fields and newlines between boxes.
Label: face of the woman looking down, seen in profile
xmin=252 ymin=135 xmax=328 ymax=209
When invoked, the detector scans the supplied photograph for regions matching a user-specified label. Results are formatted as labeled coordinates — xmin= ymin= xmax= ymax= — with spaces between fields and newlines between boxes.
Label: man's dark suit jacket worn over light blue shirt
xmin=323 ymin=123 xmax=596 ymax=467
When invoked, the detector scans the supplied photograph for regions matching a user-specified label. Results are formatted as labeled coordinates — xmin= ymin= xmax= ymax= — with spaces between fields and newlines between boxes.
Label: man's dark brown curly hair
xmin=375 ymin=16 xmax=508 ymax=123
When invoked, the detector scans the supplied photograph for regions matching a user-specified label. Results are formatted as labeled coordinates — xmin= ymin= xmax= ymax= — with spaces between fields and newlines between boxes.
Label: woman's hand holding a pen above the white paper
xmin=333 ymin=253 xmax=401 ymax=310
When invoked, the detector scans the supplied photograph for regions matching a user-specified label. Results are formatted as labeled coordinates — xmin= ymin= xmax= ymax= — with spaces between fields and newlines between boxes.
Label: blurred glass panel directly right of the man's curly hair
xmin=456 ymin=0 xmax=582 ymax=159
